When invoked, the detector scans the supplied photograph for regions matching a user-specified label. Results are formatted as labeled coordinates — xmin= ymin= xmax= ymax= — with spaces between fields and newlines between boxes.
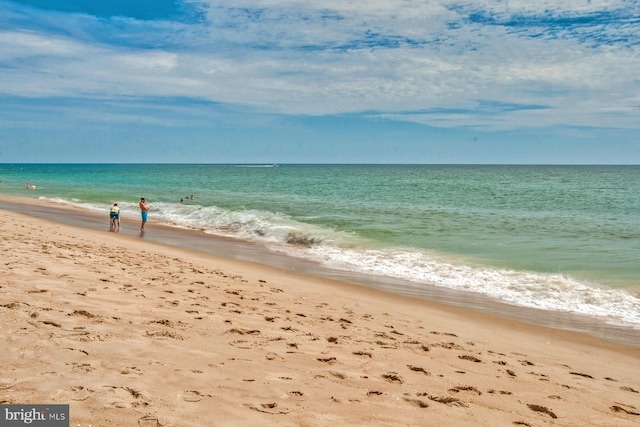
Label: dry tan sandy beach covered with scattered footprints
xmin=0 ymin=206 xmax=640 ymax=427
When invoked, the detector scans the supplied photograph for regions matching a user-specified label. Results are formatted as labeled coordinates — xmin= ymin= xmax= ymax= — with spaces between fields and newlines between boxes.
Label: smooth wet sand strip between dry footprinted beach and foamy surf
xmin=0 ymin=195 xmax=640 ymax=349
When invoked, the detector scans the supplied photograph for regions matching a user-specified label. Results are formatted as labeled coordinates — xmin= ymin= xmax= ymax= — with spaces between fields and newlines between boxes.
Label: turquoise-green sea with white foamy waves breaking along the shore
xmin=0 ymin=164 xmax=640 ymax=329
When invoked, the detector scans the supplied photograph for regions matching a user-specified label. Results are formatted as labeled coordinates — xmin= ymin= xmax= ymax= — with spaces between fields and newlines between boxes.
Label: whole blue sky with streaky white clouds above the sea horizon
xmin=0 ymin=0 xmax=640 ymax=164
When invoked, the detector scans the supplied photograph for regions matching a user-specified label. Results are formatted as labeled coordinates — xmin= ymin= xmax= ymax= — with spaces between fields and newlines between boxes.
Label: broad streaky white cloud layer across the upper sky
xmin=0 ymin=0 xmax=640 ymax=129
